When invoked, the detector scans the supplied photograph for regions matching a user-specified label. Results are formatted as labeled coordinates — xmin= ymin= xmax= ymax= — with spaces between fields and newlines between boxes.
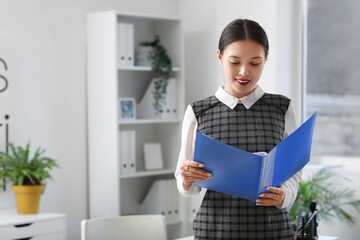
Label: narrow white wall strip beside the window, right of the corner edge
xmin=275 ymin=0 xmax=303 ymax=121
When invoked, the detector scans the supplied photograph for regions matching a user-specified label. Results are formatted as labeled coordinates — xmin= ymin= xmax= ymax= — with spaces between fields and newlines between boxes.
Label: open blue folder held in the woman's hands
xmin=194 ymin=111 xmax=317 ymax=202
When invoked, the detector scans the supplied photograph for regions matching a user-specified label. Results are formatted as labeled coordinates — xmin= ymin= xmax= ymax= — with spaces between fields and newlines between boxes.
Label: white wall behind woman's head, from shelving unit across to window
xmin=180 ymin=0 xmax=301 ymax=117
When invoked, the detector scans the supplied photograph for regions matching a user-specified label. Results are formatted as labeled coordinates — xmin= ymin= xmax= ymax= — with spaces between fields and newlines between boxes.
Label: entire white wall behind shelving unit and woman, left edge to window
xmin=0 ymin=0 xmax=358 ymax=239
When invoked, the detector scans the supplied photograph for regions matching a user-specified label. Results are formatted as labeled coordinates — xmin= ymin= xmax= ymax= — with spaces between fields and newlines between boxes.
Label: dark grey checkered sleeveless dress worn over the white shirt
xmin=191 ymin=93 xmax=294 ymax=240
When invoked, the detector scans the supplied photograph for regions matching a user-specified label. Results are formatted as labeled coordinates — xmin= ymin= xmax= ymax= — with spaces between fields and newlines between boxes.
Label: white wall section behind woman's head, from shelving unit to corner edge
xmin=180 ymin=0 xmax=286 ymax=106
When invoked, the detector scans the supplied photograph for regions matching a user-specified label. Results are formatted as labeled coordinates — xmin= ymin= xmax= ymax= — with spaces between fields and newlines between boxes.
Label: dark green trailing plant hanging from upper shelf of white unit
xmin=139 ymin=35 xmax=173 ymax=116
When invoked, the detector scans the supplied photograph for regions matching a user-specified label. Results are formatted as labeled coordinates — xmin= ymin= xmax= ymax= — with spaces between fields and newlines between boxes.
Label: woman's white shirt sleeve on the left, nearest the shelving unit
xmin=175 ymin=105 xmax=201 ymax=197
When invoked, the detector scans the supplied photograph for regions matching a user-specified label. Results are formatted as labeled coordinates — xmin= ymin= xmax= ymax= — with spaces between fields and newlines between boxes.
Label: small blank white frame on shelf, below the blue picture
xmin=144 ymin=142 xmax=164 ymax=170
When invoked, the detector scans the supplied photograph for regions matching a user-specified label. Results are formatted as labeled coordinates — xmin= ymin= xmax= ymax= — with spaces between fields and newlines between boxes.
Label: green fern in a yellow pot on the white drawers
xmin=0 ymin=142 xmax=59 ymax=214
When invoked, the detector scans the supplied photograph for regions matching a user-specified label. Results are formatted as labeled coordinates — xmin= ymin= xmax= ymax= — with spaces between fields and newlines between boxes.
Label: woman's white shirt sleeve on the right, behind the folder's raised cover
xmin=276 ymin=102 xmax=302 ymax=208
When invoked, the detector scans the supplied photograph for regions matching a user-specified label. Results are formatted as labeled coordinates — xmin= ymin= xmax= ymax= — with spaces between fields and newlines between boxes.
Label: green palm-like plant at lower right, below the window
xmin=289 ymin=167 xmax=360 ymax=229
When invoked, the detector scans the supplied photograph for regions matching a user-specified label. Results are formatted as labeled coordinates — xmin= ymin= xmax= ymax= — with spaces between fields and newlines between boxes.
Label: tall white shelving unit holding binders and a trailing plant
xmin=87 ymin=11 xmax=187 ymax=239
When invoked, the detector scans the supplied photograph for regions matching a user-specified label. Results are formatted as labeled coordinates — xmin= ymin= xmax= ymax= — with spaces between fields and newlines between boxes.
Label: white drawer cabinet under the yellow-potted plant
xmin=0 ymin=209 xmax=66 ymax=240
